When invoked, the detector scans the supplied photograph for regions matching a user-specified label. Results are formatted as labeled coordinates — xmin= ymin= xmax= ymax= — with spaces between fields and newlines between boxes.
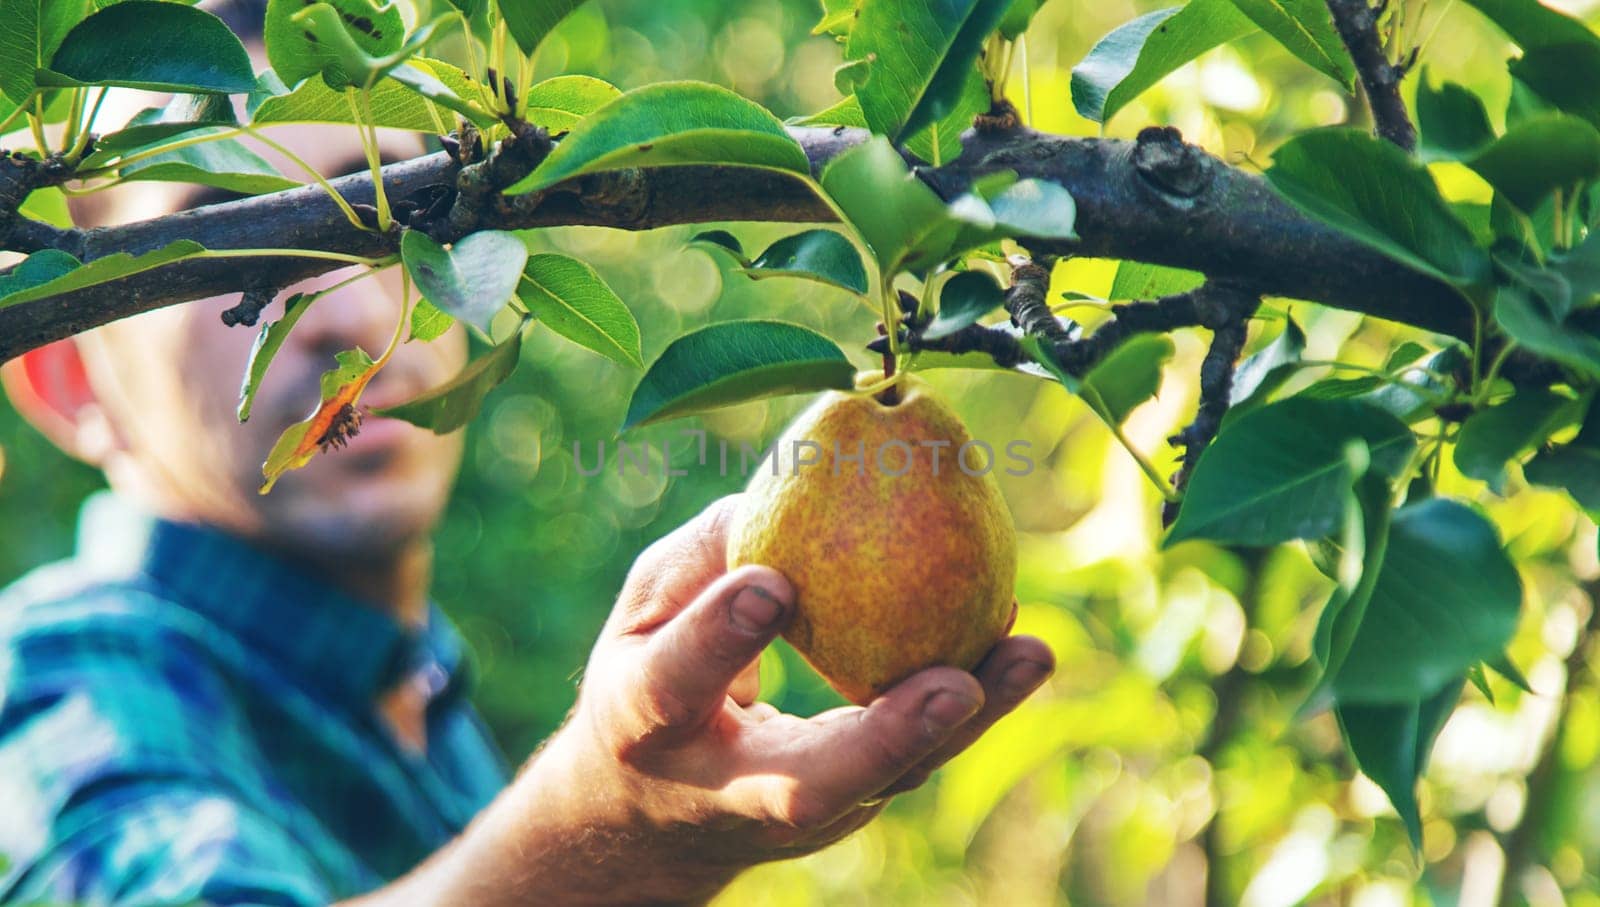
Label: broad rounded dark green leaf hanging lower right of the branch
xmin=1331 ymin=497 xmax=1522 ymax=704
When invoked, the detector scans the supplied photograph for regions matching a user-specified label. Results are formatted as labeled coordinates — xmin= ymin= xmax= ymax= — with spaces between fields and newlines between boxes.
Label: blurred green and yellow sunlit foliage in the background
xmin=0 ymin=0 xmax=1600 ymax=907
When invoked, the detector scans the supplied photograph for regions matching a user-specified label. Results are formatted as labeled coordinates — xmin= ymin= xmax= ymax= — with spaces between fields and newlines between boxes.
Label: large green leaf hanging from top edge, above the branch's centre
xmin=845 ymin=0 xmax=1010 ymax=144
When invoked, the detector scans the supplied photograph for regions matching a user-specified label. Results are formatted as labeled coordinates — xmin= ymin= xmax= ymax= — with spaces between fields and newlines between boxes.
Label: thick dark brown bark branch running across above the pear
xmin=0 ymin=128 xmax=1472 ymax=362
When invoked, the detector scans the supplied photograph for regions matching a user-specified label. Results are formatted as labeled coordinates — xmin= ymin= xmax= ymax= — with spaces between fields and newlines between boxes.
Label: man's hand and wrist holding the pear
xmin=369 ymin=497 xmax=1053 ymax=904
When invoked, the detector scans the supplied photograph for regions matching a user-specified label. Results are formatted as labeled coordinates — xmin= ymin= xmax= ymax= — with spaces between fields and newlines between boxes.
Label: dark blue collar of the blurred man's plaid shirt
xmin=77 ymin=491 xmax=470 ymax=709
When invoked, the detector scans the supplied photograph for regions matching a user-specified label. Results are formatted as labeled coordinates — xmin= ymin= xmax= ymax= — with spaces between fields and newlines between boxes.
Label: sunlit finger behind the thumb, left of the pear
xmin=611 ymin=494 xmax=741 ymax=633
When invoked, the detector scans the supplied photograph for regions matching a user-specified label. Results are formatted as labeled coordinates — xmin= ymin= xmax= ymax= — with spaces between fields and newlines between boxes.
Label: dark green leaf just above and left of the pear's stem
xmin=622 ymin=320 xmax=856 ymax=430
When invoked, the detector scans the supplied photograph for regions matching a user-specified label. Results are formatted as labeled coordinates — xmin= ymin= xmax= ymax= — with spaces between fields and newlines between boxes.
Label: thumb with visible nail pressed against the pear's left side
xmin=622 ymin=565 xmax=794 ymax=739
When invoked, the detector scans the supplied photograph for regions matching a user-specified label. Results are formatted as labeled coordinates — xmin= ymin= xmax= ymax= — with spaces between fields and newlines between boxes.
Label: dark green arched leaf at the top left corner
xmin=37 ymin=0 xmax=256 ymax=94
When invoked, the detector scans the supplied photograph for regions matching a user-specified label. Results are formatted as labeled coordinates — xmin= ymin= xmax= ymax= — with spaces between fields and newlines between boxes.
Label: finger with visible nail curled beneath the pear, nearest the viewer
xmin=752 ymin=667 xmax=984 ymax=829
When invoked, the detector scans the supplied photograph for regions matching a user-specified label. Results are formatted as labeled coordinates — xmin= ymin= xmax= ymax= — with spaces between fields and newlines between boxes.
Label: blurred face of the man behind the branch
xmin=82 ymin=126 xmax=467 ymax=557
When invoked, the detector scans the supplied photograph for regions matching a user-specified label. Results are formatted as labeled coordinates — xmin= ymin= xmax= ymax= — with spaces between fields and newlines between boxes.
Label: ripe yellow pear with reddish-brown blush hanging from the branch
xmin=728 ymin=373 xmax=1016 ymax=704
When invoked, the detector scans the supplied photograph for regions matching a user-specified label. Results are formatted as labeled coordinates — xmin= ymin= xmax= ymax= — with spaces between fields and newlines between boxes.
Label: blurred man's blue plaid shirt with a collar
xmin=0 ymin=493 xmax=507 ymax=907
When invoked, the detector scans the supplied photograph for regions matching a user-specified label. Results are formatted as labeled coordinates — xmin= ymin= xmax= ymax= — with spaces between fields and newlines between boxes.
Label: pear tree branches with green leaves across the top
xmin=0 ymin=0 xmax=1600 ymax=904
